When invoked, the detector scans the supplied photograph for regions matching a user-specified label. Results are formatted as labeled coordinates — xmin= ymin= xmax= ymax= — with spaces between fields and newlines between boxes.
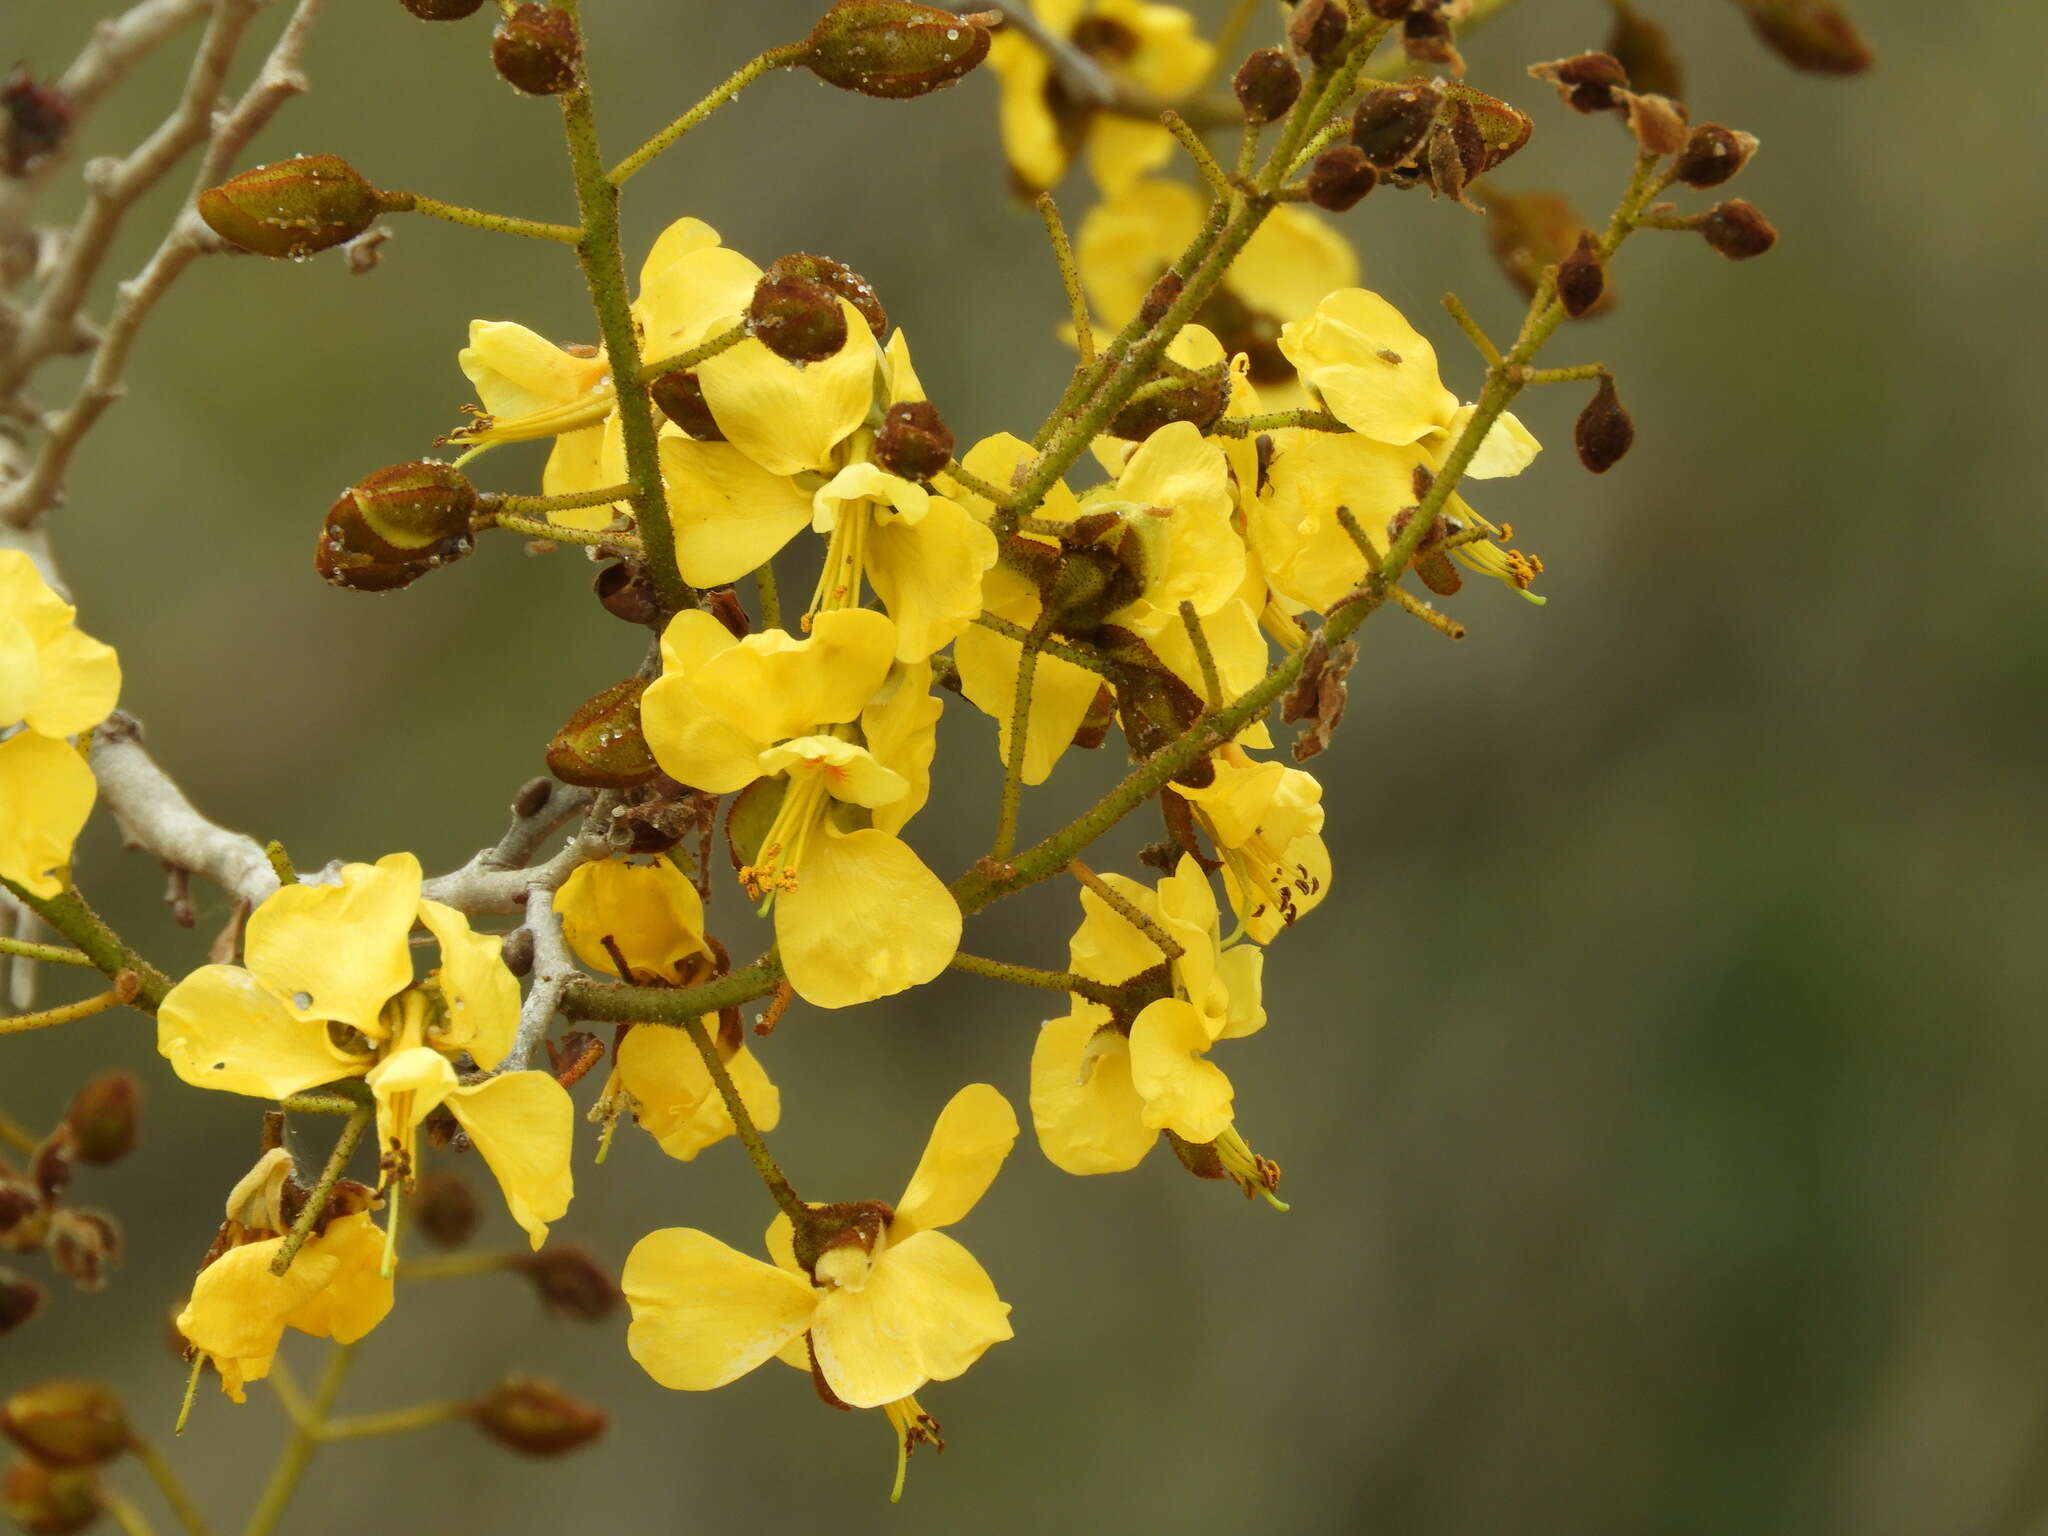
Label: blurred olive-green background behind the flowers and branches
xmin=0 ymin=0 xmax=2048 ymax=1536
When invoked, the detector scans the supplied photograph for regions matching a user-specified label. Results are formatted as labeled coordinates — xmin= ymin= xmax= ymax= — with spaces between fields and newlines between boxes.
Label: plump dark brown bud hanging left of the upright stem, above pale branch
xmin=313 ymin=459 xmax=477 ymax=592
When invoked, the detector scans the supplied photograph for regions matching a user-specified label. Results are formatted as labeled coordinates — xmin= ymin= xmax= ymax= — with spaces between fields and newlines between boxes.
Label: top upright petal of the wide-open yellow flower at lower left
xmin=244 ymin=854 xmax=420 ymax=1030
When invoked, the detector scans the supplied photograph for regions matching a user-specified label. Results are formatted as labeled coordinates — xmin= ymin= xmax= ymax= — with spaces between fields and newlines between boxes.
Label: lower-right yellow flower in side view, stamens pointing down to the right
xmin=1030 ymin=856 xmax=1266 ymax=1204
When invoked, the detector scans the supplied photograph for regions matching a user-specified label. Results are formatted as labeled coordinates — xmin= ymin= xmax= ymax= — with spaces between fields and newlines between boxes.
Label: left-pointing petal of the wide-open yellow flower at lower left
xmin=156 ymin=965 xmax=369 ymax=1098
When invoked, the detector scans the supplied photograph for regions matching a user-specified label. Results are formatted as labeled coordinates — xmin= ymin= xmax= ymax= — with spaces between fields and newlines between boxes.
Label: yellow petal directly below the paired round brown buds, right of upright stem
xmin=696 ymin=309 xmax=881 ymax=475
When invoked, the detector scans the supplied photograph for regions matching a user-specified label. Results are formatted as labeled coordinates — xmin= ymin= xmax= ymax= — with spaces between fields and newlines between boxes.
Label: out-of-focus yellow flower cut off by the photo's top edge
xmin=989 ymin=0 xmax=1217 ymax=195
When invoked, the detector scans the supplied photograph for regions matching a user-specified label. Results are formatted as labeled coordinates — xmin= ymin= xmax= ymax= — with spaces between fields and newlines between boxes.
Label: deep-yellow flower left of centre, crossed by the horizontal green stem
xmin=555 ymin=858 xmax=782 ymax=1163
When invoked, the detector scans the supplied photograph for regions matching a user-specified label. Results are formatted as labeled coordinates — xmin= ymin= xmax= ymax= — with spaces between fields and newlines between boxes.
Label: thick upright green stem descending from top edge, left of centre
xmin=557 ymin=0 xmax=696 ymax=612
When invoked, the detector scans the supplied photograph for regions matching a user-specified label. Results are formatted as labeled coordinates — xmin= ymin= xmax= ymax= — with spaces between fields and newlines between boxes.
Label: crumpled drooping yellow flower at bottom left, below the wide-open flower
xmin=178 ymin=1147 xmax=391 ymax=1403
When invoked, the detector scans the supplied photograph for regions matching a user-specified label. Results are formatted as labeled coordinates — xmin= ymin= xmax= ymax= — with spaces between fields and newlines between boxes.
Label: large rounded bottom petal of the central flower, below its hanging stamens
xmin=774 ymin=821 xmax=961 ymax=1008
